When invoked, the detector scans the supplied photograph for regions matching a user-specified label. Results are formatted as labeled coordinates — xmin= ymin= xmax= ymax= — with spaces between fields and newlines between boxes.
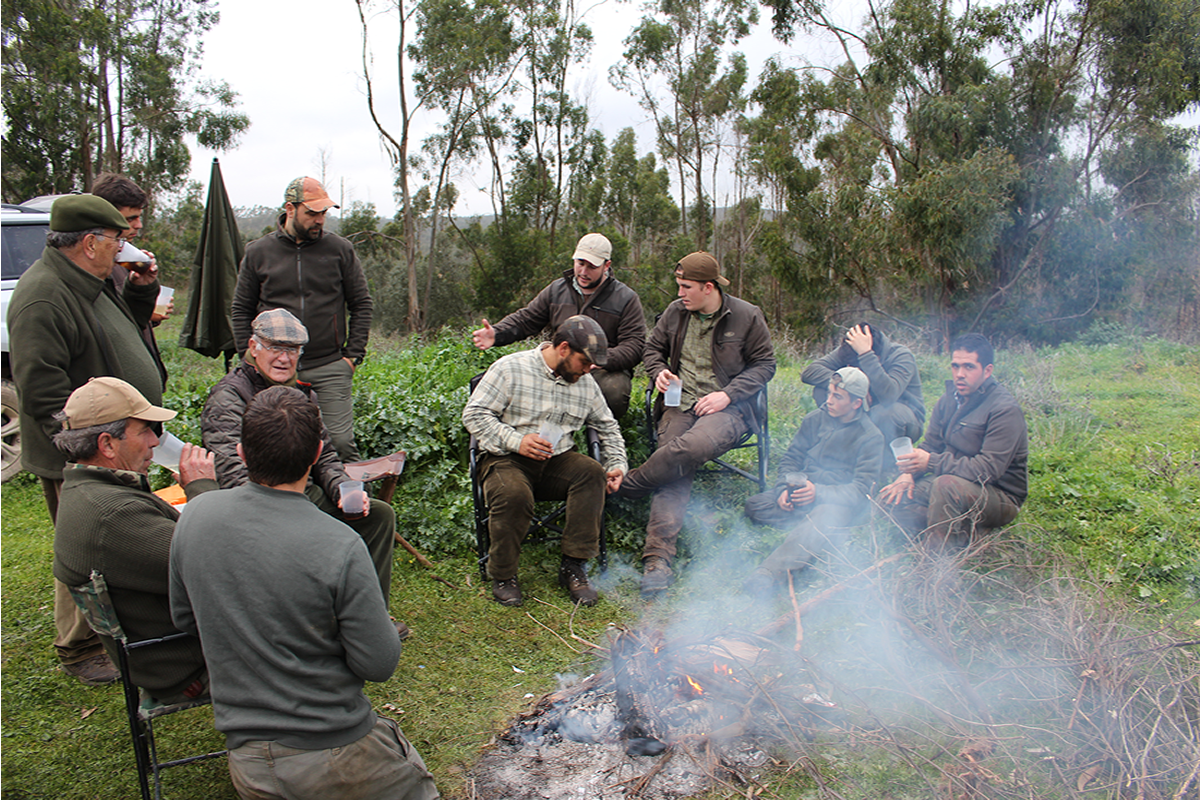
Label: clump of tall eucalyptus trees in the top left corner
xmin=2 ymin=0 xmax=250 ymax=200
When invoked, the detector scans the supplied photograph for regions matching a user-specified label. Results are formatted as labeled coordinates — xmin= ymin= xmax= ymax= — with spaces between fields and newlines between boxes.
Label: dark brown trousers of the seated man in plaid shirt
xmin=479 ymin=450 xmax=605 ymax=581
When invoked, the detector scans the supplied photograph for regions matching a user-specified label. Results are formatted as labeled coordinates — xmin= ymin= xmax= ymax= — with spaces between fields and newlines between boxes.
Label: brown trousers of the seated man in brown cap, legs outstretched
xmin=620 ymin=408 xmax=748 ymax=564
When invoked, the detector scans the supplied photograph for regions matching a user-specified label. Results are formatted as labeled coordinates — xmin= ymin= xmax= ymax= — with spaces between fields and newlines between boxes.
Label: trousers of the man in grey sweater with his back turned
xmin=229 ymin=717 xmax=438 ymax=800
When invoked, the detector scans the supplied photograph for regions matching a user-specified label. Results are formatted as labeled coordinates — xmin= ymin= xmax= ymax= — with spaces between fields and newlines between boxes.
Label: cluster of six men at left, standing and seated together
xmin=8 ymin=176 xmax=438 ymax=800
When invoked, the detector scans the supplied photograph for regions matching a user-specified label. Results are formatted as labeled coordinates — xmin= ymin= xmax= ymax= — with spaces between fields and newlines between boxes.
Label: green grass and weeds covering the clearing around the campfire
xmin=0 ymin=316 xmax=1200 ymax=800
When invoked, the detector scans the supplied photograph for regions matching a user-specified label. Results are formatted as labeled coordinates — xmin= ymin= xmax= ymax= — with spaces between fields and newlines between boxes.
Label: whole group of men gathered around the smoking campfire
xmin=8 ymin=170 xmax=1026 ymax=798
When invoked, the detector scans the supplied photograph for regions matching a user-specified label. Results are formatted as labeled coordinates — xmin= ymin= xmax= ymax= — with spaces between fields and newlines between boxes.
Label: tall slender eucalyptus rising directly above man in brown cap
xmin=610 ymin=0 xmax=758 ymax=248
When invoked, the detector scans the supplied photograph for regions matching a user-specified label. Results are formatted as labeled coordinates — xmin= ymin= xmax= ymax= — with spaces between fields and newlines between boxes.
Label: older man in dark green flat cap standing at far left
xmin=8 ymin=194 xmax=162 ymax=685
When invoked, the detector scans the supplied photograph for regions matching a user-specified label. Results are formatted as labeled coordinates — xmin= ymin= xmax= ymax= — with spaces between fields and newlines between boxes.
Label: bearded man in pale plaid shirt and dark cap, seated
xmin=462 ymin=317 xmax=629 ymax=606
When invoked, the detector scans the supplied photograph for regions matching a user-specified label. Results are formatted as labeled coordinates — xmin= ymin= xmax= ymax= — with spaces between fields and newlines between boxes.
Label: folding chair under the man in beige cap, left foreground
xmin=70 ymin=571 xmax=226 ymax=800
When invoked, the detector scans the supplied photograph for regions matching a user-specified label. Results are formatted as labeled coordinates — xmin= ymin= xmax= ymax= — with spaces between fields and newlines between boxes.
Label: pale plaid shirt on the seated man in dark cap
xmin=462 ymin=344 xmax=629 ymax=473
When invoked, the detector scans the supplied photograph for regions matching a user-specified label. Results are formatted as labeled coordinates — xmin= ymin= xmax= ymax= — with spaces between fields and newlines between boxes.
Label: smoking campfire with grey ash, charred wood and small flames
xmin=463 ymin=630 xmax=838 ymax=800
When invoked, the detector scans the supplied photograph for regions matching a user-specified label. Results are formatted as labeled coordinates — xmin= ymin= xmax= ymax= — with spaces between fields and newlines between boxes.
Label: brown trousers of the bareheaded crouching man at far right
xmin=893 ymin=475 xmax=1021 ymax=549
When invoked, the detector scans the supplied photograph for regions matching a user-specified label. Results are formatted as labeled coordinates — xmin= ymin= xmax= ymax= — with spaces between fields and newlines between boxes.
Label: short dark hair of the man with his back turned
xmin=241 ymin=386 xmax=322 ymax=486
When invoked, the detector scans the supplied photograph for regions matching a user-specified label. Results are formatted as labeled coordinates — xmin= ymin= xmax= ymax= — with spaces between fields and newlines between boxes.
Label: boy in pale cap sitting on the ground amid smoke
xmin=744 ymin=367 xmax=883 ymax=595
